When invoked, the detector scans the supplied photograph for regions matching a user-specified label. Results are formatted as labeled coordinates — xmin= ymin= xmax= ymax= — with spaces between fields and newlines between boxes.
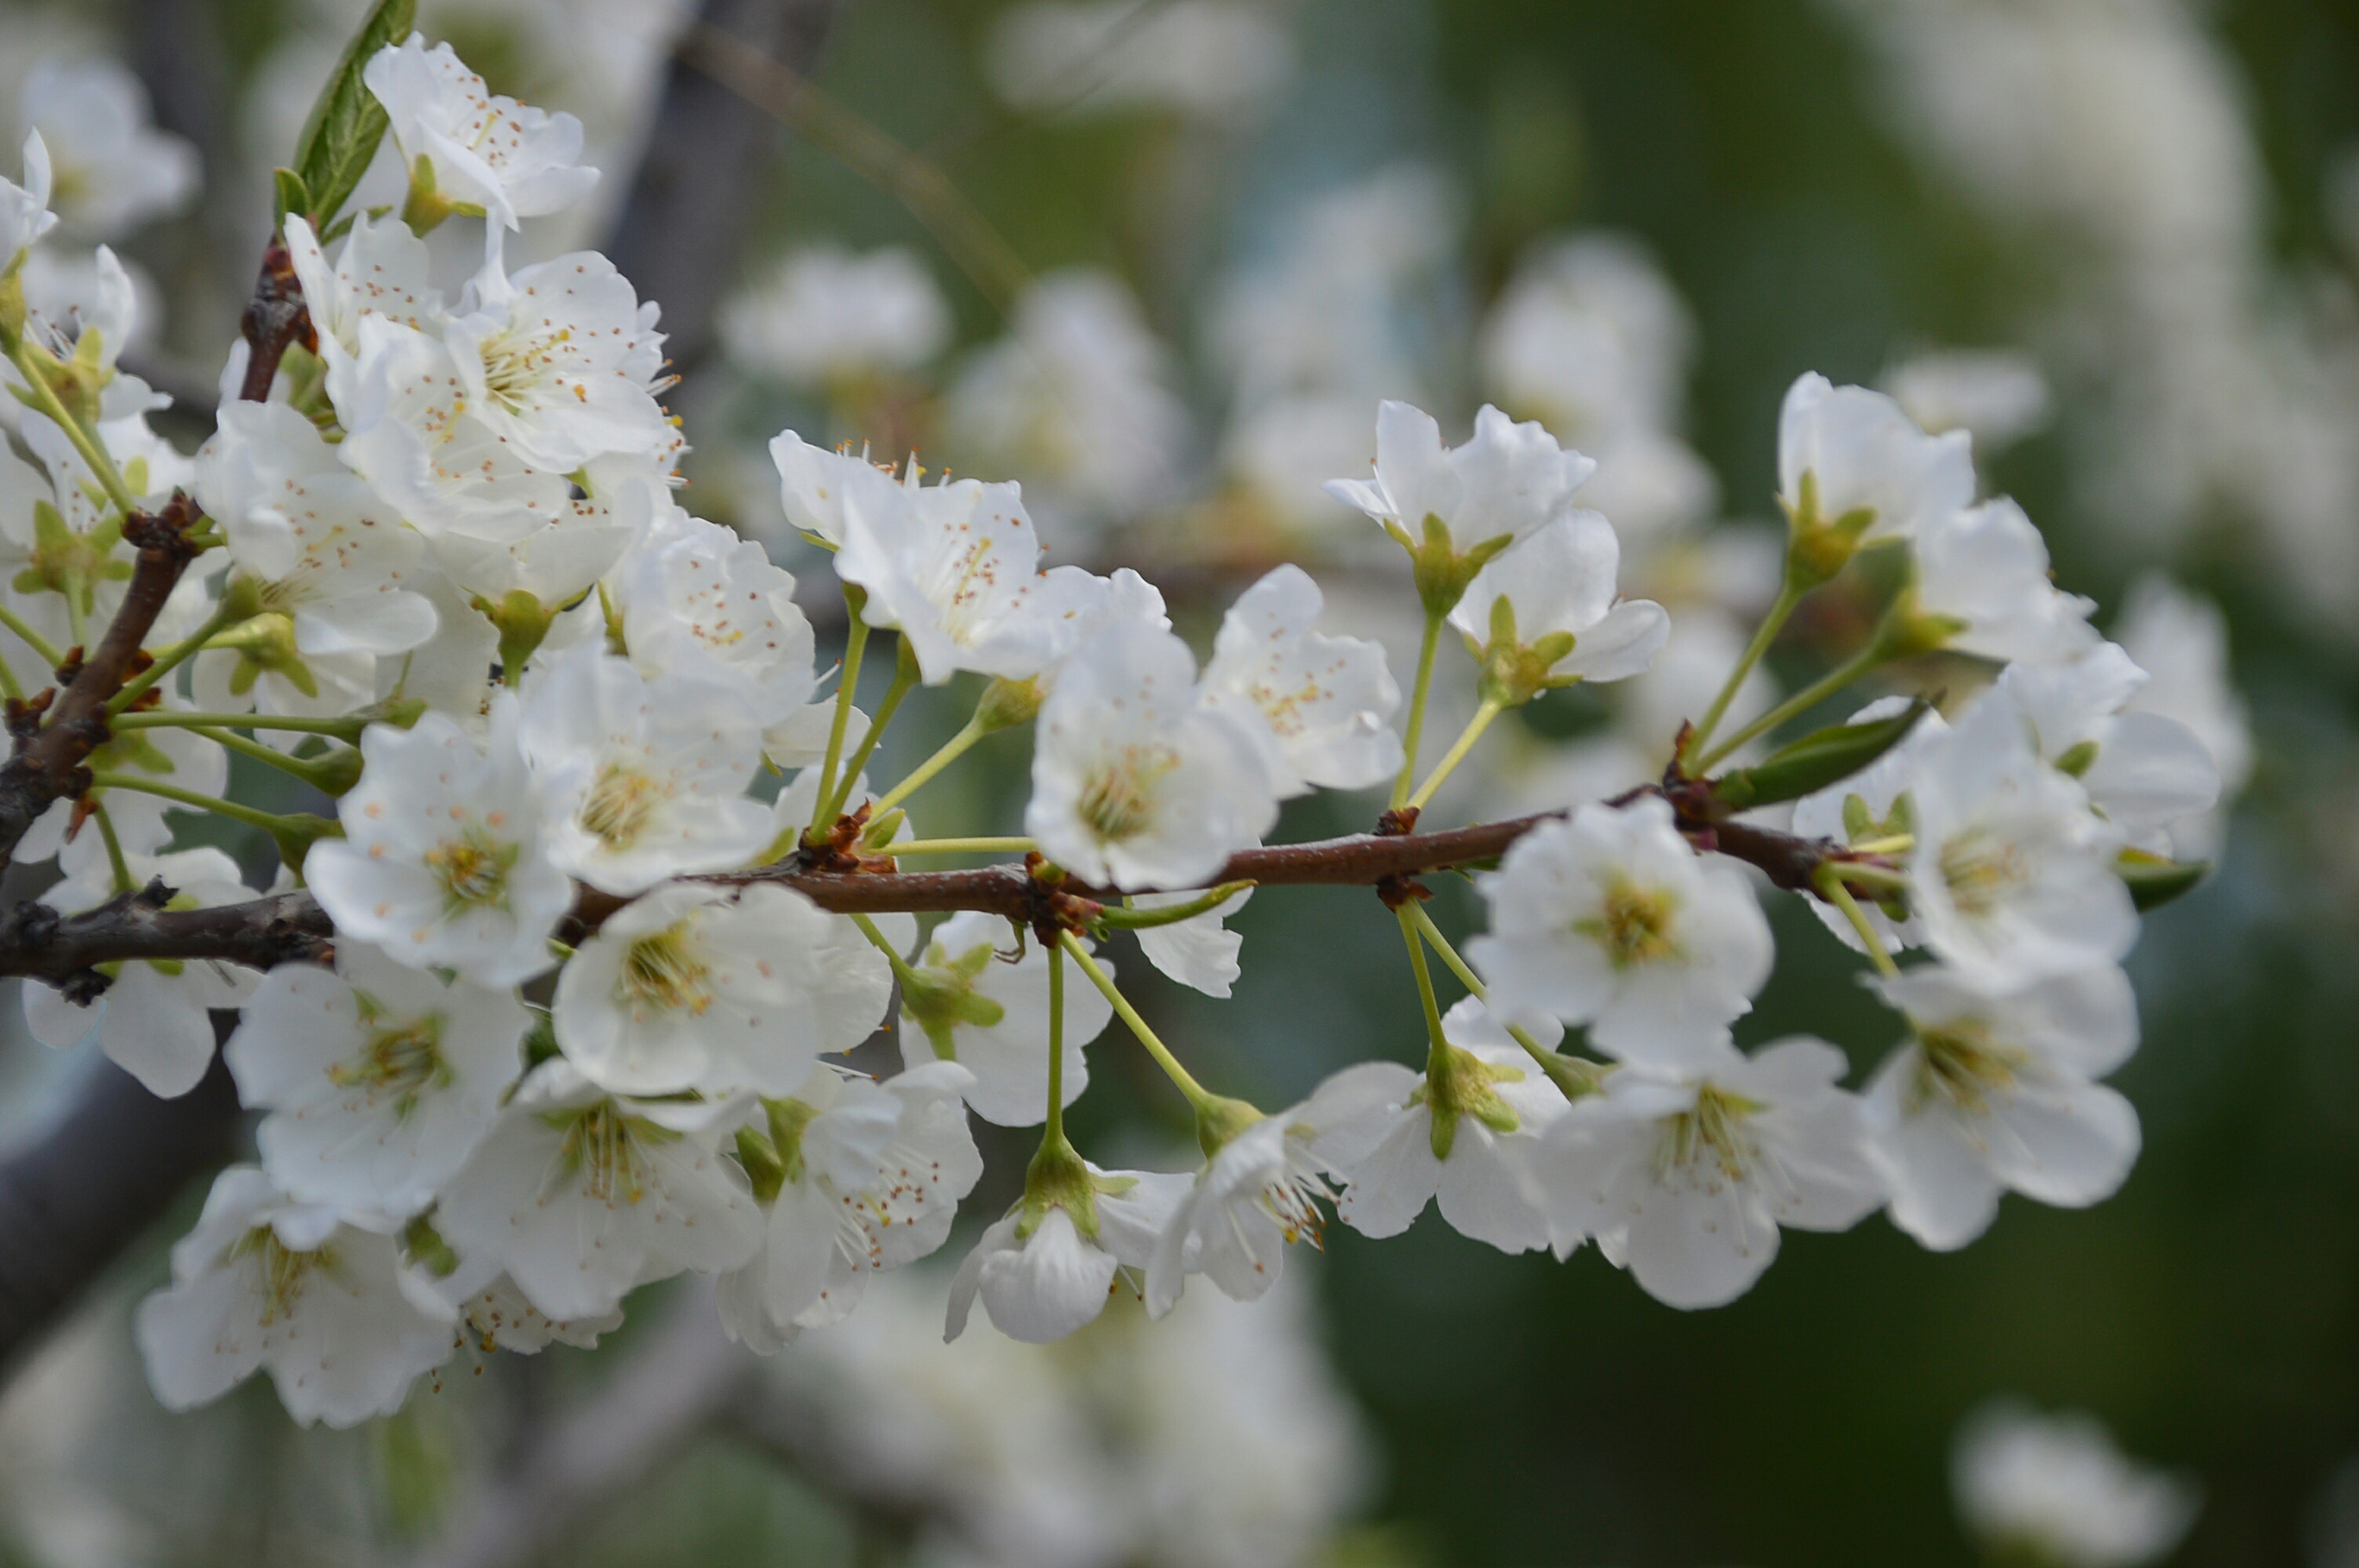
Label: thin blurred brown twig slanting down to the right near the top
xmin=679 ymin=24 xmax=1030 ymax=316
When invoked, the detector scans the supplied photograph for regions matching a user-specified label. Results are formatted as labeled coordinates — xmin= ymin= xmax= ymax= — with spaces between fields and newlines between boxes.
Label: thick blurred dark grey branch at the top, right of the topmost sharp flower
xmin=606 ymin=0 xmax=840 ymax=375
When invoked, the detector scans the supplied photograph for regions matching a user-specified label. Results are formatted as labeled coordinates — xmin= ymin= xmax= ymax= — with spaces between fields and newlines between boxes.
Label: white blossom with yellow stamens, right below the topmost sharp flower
xmin=444 ymin=250 xmax=672 ymax=474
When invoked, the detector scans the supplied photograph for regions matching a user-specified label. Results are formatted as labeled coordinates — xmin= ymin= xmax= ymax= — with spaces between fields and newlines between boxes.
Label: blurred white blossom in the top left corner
xmin=19 ymin=56 xmax=201 ymax=241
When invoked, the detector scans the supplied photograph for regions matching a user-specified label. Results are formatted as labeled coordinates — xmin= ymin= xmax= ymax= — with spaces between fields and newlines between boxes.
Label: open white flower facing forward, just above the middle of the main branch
xmin=1023 ymin=620 xmax=1278 ymax=887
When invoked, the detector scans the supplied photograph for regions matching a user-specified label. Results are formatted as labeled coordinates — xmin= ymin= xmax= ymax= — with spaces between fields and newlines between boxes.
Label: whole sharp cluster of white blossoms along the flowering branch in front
xmin=0 ymin=18 xmax=2220 ymax=1425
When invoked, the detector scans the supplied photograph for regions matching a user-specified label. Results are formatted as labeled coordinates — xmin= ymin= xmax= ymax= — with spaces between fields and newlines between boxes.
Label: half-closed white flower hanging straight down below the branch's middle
xmin=943 ymin=1165 xmax=1191 ymax=1344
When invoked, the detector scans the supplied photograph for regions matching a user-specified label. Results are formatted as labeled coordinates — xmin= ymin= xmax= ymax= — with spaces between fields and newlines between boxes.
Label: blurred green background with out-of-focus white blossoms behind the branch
xmin=0 ymin=0 xmax=2359 ymax=1568
